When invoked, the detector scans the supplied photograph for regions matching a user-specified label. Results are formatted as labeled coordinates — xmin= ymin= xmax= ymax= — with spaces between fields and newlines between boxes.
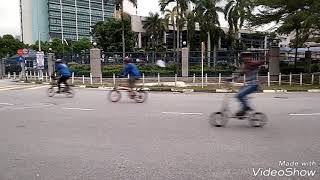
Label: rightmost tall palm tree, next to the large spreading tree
xmin=223 ymin=0 xmax=253 ymax=40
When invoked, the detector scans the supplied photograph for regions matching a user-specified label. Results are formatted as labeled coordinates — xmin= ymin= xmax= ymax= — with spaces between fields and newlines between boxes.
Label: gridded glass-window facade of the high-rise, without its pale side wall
xmin=48 ymin=0 xmax=115 ymax=40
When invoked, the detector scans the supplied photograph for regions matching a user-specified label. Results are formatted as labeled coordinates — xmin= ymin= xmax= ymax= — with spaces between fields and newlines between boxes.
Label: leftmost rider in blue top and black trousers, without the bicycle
xmin=56 ymin=59 xmax=71 ymax=93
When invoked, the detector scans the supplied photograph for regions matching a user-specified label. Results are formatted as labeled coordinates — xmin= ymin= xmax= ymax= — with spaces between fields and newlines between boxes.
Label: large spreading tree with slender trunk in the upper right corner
xmin=251 ymin=0 xmax=320 ymax=68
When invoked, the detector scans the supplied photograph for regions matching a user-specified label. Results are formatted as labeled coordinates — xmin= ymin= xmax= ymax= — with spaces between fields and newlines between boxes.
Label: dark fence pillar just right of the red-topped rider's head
xmin=269 ymin=46 xmax=280 ymax=75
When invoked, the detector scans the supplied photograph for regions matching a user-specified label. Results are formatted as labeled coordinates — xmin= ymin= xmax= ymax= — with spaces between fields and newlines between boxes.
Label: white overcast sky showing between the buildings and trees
xmin=0 ymin=0 xmax=242 ymax=35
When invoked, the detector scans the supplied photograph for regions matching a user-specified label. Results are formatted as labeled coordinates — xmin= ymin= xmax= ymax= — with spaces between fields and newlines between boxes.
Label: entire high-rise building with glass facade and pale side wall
xmin=20 ymin=0 xmax=115 ymax=44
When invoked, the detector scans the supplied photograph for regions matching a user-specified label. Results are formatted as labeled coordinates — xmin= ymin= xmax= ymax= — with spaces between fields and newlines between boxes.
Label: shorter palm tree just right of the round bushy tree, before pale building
xmin=143 ymin=13 xmax=167 ymax=48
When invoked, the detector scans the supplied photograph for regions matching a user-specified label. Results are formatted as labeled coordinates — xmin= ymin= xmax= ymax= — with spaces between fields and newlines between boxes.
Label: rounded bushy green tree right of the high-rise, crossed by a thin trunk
xmin=92 ymin=18 xmax=135 ymax=52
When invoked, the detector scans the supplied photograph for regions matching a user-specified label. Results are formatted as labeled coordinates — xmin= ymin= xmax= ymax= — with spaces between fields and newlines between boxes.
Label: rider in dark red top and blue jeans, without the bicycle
xmin=236 ymin=58 xmax=264 ymax=116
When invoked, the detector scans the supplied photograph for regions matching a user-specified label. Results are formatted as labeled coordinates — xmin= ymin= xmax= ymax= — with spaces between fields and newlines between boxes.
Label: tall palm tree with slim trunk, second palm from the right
xmin=195 ymin=0 xmax=223 ymax=66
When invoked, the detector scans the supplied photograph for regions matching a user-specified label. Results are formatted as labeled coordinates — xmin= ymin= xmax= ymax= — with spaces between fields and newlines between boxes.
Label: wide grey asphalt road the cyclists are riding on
xmin=0 ymin=82 xmax=320 ymax=180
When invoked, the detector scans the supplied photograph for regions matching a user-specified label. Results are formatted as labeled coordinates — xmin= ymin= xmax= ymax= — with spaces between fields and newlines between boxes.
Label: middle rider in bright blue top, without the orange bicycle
xmin=121 ymin=57 xmax=141 ymax=95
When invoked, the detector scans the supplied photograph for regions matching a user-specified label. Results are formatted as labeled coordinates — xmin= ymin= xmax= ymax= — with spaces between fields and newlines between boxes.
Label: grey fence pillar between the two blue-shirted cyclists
xmin=90 ymin=48 xmax=101 ymax=78
